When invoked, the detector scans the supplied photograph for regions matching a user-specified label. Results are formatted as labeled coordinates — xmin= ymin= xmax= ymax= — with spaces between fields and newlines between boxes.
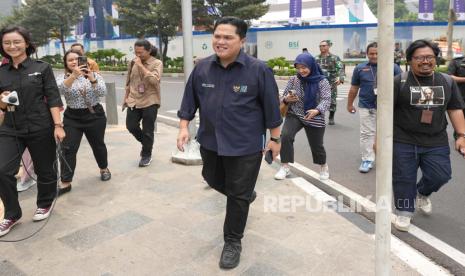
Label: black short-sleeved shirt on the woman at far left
xmin=0 ymin=58 xmax=63 ymax=135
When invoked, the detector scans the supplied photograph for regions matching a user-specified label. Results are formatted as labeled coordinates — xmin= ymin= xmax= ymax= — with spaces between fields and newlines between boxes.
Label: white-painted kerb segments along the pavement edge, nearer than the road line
xmin=291 ymin=177 xmax=451 ymax=276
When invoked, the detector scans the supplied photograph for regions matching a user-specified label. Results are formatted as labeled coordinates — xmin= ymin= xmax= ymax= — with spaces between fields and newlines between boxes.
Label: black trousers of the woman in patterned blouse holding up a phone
xmin=61 ymin=104 xmax=108 ymax=182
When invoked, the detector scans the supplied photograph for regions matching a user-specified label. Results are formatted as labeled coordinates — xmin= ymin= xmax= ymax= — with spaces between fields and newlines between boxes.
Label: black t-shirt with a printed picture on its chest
xmin=394 ymin=72 xmax=464 ymax=147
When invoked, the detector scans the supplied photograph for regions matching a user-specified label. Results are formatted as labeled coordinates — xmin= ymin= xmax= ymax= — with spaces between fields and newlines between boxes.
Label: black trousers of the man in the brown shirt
xmin=126 ymin=105 xmax=158 ymax=157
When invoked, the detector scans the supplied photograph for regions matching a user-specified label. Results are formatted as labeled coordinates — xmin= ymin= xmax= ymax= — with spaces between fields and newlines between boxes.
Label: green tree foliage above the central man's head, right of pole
xmin=192 ymin=0 xmax=269 ymax=28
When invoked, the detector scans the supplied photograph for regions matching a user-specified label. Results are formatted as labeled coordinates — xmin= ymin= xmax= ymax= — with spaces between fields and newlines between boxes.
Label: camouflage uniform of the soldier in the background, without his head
xmin=316 ymin=53 xmax=345 ymax=112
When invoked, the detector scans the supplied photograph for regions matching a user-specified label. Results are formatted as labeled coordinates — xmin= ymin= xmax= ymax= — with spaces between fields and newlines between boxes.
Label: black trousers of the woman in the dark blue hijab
xmin=280 ymin=114 xmax=326 ymax=165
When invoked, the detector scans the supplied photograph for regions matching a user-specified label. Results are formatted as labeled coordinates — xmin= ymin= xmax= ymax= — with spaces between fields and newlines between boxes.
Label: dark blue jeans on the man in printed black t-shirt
xmin=392 ymin=143 xmax=452 ymax=215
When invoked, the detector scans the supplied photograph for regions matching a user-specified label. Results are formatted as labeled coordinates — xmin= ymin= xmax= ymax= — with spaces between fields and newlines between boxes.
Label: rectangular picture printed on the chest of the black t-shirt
xmin=410 ymin=86 xmax=444 ymax=107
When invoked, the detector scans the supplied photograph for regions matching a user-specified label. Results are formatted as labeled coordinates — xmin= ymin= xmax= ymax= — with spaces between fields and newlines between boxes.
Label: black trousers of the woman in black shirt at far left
xmin=0 ymin=128 xmax=57 ymax=219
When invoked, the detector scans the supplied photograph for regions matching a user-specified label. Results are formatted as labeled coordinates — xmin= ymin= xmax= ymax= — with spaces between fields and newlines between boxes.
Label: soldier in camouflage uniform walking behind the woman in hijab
xmin=315 ymin=40 xmax=345 ymax=125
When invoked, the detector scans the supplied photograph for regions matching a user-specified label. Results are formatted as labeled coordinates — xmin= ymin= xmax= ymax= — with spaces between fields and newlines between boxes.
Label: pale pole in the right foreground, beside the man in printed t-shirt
xmin=375 ymin=0 xmax=394 ymax=276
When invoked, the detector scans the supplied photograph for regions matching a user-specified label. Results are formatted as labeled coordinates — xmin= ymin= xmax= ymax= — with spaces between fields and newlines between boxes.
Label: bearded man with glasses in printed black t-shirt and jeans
xmin=392 ymin=39 xmax=465 ymax=231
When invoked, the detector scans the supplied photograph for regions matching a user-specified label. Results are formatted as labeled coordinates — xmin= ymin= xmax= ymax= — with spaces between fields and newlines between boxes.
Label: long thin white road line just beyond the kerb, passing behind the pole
xmin=290 ymin=162 xmax=465 ymax=266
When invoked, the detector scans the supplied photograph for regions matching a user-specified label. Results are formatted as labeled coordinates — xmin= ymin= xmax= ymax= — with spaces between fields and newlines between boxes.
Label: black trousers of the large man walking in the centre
xmin=200 ymin=147 xmax=262 ymax=242
